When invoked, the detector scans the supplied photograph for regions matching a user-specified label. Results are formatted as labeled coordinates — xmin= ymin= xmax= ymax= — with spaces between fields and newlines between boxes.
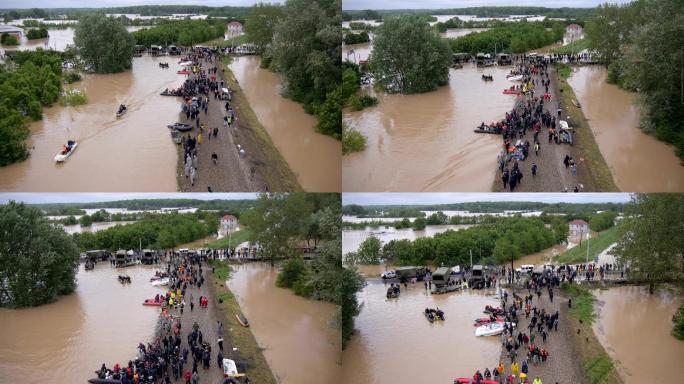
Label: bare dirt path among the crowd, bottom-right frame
xmin=500 ymin=288 xmax=586 ymax=384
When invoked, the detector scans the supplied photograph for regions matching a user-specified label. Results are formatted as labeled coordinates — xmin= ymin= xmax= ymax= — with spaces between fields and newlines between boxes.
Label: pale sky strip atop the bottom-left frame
xmin=0 ymin=193 xmax=257 ymax=204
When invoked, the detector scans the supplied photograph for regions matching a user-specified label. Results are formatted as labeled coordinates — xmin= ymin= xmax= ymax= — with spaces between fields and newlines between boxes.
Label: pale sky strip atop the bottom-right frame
xmin=342 ymin=193 xmax=630 ymax=205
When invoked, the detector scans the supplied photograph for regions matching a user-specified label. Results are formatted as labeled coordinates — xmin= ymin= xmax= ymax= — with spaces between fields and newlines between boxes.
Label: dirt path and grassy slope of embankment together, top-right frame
xmin=491 ymin=66 xmax=618 ymax=192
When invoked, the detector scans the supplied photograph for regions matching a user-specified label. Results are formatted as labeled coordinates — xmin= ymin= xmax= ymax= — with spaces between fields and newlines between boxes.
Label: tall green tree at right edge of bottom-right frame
xmin=612 ymin=193 xmax=684 ymax=293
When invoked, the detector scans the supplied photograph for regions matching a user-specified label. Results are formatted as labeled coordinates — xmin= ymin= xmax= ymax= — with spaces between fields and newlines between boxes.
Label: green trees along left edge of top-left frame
xmin=0 ymin=49 xmax=62 ymax=166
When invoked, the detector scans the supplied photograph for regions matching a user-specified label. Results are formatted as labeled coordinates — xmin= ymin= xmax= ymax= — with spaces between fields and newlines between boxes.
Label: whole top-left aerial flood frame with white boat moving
xmin=0 ymin=0 xmax=341 ymax=192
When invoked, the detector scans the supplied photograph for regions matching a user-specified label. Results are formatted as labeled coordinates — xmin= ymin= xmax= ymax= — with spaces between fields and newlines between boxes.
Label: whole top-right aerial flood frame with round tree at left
xmin=342 ymin=0 xmax=684 ymax=192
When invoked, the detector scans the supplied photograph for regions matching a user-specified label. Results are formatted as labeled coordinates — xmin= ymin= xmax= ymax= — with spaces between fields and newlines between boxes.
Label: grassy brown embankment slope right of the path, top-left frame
xmin=219 ymin=56 xmax=302 ymax=191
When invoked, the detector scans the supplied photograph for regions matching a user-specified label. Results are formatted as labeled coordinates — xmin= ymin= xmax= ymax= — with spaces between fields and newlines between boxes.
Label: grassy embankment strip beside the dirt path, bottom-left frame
xmin=209 ymin=260 xmax=276 ymax=384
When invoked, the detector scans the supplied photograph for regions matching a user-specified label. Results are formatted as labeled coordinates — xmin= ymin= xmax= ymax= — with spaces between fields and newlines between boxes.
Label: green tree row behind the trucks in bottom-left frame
xmin=73 ymin=213 xmax=219 ymax=251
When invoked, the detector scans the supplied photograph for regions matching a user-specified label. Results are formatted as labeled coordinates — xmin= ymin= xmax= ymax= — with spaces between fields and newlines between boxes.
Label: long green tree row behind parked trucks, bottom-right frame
xmin=346 ymin=217 xmax=568 ymax=266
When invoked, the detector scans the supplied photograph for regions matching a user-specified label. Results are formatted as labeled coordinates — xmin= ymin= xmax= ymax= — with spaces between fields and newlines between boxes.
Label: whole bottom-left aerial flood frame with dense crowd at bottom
xmin=0 ymin=192 xmax=341 ymax=384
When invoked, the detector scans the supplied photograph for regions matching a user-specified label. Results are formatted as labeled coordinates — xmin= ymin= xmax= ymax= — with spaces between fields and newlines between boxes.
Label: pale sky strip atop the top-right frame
xmin=342 ymin=0 xmax=632 ymax=10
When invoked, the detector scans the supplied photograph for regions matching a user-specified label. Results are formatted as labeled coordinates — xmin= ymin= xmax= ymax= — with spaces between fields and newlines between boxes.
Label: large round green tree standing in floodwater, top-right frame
xmin=370 ymin=15 xmax=452 ymax=93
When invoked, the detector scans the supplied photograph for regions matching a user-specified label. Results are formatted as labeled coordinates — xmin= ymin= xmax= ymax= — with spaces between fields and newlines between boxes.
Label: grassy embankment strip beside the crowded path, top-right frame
xmin=557 ymin=64 xmax=619 ymax=192
